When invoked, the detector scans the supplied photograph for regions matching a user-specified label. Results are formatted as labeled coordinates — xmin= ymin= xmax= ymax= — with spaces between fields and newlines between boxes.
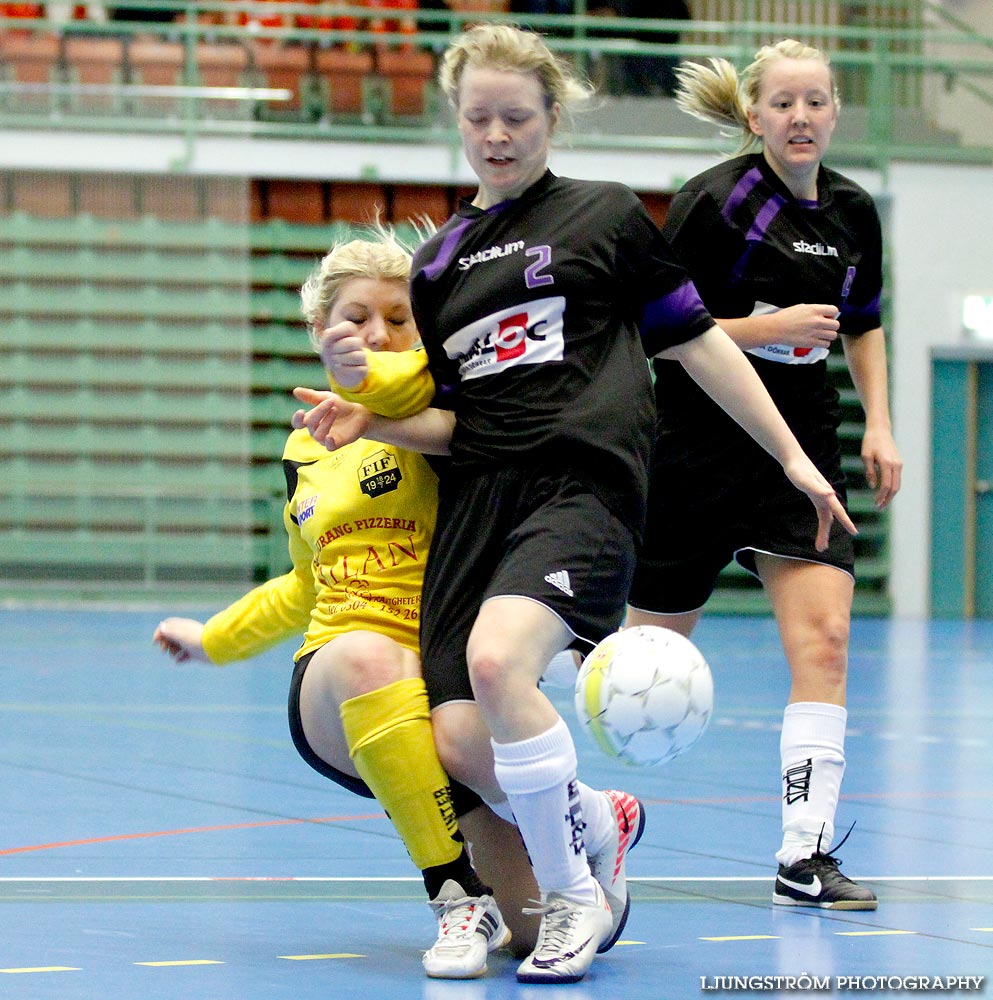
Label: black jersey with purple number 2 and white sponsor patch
xmin=411 ymin=172 xmax=713 ymax=534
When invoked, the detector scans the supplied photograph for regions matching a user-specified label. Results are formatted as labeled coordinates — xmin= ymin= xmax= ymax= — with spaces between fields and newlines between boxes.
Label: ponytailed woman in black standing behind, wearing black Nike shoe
xmin=627 ymin=40 xmax=901 ymax=910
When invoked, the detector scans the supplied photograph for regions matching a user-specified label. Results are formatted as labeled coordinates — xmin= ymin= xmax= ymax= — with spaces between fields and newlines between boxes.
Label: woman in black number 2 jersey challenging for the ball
xmin=296 ymin=25 xmax=850 ymax=983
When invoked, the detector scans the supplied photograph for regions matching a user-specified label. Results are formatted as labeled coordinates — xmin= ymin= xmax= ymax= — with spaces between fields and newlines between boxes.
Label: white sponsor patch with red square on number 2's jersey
xmin=445 ymin=295 xmax=565 ymax=380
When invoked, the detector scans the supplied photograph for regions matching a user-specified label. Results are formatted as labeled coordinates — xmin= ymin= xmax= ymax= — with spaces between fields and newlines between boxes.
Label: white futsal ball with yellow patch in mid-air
xmin=576 ymin=625 xmax=714 ymax=765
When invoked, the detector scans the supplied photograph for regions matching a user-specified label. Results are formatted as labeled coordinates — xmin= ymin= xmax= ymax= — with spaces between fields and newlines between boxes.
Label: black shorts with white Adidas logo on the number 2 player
xmin=421 ymin=467 xmax=635 ymax=707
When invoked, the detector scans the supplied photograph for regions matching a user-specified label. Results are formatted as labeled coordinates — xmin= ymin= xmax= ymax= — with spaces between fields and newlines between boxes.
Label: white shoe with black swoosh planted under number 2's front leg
xmin=517 ymin=882 xmax=613 ymax=983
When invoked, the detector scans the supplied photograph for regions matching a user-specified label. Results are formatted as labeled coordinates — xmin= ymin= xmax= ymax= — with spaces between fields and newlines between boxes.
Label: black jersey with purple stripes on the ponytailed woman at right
xmin=655 ymin=154 xmax=882 ymax=495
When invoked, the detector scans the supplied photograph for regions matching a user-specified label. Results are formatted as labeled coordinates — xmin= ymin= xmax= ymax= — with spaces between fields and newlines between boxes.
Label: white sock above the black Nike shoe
xmin=776 ymin=701 xmax=848 ymax=865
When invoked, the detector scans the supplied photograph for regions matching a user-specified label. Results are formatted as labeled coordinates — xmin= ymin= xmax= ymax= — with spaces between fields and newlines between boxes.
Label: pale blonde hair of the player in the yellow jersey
xmin=300 ymin=222 xmax=414 ymax=351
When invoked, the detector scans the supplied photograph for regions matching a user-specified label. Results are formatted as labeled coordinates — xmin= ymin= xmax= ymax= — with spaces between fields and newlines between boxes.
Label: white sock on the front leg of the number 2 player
xmin=493 ymin=718 xmax=596 ymax=904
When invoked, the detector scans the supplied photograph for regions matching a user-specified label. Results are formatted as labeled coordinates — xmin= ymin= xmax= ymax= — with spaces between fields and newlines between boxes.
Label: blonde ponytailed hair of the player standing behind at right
xmin=676 ymin=38 xmax=841 ymax=153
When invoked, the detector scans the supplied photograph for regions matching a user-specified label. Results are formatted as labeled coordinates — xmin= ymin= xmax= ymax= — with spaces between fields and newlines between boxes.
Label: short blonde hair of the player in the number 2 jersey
xmin=438 ymin=24 xmax=593 ymax=111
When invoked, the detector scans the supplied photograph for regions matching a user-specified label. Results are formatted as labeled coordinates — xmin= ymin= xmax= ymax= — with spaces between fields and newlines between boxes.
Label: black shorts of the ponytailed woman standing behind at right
xmin=628 ymin=465 xmax=855 ymax=614
